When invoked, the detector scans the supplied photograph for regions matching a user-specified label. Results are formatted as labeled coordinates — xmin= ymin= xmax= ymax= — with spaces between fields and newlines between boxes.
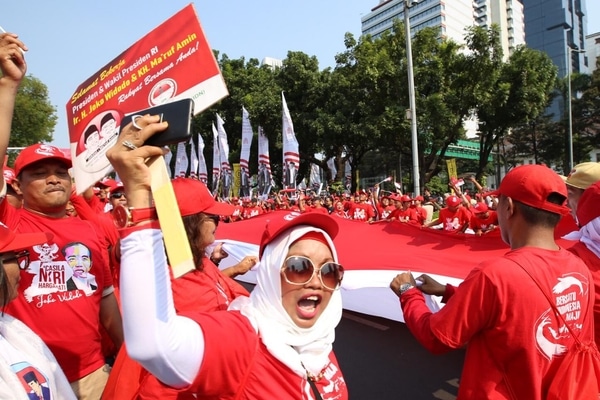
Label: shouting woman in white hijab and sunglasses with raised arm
xmin=107 ymin=115 xmax=348 ymax=400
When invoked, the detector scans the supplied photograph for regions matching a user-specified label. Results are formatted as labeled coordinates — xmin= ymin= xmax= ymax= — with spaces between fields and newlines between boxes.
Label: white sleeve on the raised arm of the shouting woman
xmin=120 ymin=229 xmax=204 ymax=388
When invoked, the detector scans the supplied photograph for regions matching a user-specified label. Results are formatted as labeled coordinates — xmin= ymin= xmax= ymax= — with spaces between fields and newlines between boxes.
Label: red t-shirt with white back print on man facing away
xmin=400 ymin=247 xmax=594 ymax=400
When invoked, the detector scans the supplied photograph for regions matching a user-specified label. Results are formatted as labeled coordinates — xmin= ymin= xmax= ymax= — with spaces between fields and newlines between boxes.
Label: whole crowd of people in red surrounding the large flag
xmin=0 ymin=33 xmax=600 ymax=400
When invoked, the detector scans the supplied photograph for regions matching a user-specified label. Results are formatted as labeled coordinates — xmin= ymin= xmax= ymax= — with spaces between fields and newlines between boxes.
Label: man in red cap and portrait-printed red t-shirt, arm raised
xmin=0 ymin=46 xmax=123 ymax=399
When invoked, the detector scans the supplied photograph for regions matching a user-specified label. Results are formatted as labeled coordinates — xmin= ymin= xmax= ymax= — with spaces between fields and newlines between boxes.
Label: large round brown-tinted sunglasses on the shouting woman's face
xmin=281 ymin=256 xmax=344 ymax=290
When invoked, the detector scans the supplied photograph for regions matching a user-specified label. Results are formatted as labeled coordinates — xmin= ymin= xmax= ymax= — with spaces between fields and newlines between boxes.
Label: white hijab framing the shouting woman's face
xmin=229 ymin=225 xmax=342 ymax=378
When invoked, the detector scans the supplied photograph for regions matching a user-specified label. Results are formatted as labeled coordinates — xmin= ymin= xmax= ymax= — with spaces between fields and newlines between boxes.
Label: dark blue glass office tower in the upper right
xmin=523 ymin=0 xmax=597 ymax=120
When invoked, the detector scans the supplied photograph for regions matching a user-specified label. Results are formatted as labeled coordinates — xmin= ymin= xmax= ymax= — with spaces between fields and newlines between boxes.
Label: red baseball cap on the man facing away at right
xmin=488 ymin=164 xmax=569 ymax=215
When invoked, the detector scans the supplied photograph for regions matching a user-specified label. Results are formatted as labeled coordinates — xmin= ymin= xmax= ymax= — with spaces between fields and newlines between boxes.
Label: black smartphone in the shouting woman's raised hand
xmin=121 ymin=99 xmax=194 ymax=147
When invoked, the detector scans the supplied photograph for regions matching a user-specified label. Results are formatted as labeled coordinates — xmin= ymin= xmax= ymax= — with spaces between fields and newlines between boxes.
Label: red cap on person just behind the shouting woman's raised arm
xmin=171 ymin=178 xmax=235 ymax=217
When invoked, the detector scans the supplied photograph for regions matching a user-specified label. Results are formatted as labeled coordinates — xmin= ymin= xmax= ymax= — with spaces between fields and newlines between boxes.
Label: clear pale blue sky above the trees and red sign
xmin=0 ymin=0 xmax=600 ymax=147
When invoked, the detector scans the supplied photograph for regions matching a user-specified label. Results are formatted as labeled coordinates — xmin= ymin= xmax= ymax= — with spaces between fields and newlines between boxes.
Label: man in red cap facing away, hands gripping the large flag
xmin=390 ymin=165 xmax=598 ymax=400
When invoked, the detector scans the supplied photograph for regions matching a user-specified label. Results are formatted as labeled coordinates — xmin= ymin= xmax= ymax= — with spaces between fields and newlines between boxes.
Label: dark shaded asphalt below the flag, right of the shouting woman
xmin=333 ymin=311 xmax=464 ymax=400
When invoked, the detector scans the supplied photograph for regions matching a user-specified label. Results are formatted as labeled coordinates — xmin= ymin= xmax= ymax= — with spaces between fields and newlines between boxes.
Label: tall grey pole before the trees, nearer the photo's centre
xmin=404 ymin=0 xmax=421 ymax=196
